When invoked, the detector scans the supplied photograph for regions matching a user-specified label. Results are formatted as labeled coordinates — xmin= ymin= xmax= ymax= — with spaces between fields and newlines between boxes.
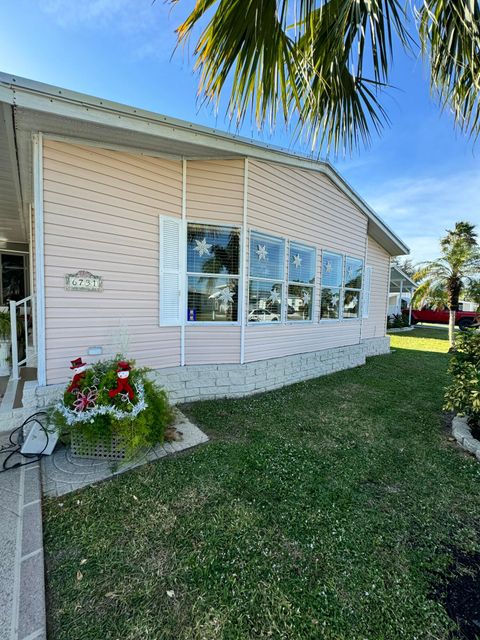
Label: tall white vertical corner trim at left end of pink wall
xmin=33 ymin=133 xmax=47 ymax=386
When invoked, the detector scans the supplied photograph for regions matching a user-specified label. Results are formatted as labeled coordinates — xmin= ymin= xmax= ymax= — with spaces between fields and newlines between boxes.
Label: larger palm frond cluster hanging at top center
xmin=172 ymin=0 xmax=410 ymax=150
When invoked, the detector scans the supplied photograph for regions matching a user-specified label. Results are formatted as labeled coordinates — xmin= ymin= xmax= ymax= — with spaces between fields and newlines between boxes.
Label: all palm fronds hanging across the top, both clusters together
xmin=169 ymin=0 xmax=480 ymax=150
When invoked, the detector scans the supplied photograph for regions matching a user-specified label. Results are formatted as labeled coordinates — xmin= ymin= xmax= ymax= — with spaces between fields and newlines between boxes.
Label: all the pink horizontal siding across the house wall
xmin=44 ymin=140 xmax=388 ymax=384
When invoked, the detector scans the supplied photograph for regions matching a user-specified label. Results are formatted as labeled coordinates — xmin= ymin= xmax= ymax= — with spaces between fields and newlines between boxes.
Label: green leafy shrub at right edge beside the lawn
xmin=445 ymin=329 xmax=480 ymax=425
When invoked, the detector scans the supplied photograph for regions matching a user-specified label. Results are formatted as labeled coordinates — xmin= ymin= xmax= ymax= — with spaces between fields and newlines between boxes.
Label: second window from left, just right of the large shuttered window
xmin=248 ymin=232 xmax=285 ymax=322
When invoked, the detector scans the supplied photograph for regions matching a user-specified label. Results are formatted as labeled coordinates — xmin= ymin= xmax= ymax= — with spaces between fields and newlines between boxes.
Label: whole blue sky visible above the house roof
xmin=0 ymin=0 xmax=480 ymax=262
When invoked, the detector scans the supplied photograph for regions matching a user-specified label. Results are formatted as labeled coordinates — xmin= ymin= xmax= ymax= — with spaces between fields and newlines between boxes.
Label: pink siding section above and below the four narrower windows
xmin=245 ymin=162 xmax=367 ymax=362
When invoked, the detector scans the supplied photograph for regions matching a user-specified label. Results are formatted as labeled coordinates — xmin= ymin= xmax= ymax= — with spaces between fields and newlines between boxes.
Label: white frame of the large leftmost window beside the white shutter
xmin=182 ymin=218 xmax=244 ymax=327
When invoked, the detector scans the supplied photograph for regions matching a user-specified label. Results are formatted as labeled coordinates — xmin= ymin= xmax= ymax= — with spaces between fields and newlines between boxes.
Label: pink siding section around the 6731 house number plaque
xmin=44 ymin=140 xmax=182 ymax=384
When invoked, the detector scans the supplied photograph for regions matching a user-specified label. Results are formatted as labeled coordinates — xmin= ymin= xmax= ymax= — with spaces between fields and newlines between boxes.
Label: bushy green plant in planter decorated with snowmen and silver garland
xmin=52 ymin=356 xmax=173 ymax=458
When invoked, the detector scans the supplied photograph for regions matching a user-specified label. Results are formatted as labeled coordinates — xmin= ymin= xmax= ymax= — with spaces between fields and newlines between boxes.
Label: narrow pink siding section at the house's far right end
xmin=362 ymin=236 xmax=390 ymax=338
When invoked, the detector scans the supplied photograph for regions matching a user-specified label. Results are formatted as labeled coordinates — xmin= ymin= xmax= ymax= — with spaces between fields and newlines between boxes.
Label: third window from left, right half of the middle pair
xmin=287 ymin=242 xmax=316 ymax=322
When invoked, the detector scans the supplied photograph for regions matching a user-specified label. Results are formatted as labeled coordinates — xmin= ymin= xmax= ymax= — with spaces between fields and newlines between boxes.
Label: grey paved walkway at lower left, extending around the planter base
xmin=0 ymin=411 xmax=208 ymax=640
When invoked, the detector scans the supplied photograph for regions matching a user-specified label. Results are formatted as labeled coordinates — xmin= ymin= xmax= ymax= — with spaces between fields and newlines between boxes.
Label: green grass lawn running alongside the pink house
xmin=44 ymin=329 xmax=480 ymax=640
